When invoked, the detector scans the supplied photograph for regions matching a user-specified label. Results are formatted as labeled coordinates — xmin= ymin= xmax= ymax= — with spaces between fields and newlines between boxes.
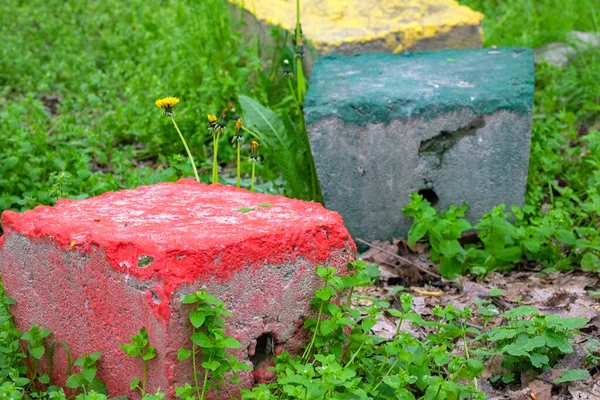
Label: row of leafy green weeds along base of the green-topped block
xmin=402 ymin=189 xmax=600 ymax=279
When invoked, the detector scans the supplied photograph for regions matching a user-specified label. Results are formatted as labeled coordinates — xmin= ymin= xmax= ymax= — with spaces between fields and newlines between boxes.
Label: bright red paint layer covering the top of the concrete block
xmin=2 ymin=179 xmax=353 ymax=322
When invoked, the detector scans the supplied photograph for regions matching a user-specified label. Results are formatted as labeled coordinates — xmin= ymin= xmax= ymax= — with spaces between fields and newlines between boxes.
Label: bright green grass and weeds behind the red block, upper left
xmin=0 ymin=0 xmax=266 ymax=210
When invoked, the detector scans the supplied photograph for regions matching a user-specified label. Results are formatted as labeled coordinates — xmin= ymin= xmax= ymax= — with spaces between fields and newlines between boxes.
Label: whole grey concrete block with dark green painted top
xmin=305 ymin=48 xmax=534 ymax=247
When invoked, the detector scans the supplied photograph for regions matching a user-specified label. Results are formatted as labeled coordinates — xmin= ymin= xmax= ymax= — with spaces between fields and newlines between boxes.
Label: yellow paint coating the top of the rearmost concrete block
xmin=229 ymin=0 xmax=483 ymax=52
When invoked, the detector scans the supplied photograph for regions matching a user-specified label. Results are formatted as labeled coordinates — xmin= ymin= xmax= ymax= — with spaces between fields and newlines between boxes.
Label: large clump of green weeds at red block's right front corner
xmin=242 ymin=261 xmax=483 ymax=400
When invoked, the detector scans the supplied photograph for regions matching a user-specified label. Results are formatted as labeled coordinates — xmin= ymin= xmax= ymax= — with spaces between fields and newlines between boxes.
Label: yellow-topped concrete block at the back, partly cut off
xmin=229 ymin=0 xmax=483 ymax=72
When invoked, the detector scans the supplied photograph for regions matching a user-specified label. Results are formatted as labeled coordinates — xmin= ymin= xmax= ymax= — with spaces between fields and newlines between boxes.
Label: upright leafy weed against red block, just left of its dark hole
xmin=175 ymin=288 xmax=251 ymax=400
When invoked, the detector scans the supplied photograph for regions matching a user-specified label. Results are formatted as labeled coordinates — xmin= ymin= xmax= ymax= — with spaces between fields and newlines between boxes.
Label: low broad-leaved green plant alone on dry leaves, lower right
xmin=477 ymin=306 xmax=589 ymax=383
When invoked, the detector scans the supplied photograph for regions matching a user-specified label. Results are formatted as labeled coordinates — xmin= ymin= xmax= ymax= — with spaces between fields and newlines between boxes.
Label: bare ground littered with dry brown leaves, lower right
xmin=361 ymin=239 xmax=600 ymax=400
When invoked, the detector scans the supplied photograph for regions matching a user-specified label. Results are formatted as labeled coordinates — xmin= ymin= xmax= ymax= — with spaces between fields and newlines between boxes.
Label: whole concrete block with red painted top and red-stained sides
xmin=0 ymin=180 xmax=355 ymax=398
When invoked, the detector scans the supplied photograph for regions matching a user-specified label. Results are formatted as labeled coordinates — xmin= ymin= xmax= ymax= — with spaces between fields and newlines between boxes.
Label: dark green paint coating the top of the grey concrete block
xmin=305 ymin=47 xmax=534 ymax=126
